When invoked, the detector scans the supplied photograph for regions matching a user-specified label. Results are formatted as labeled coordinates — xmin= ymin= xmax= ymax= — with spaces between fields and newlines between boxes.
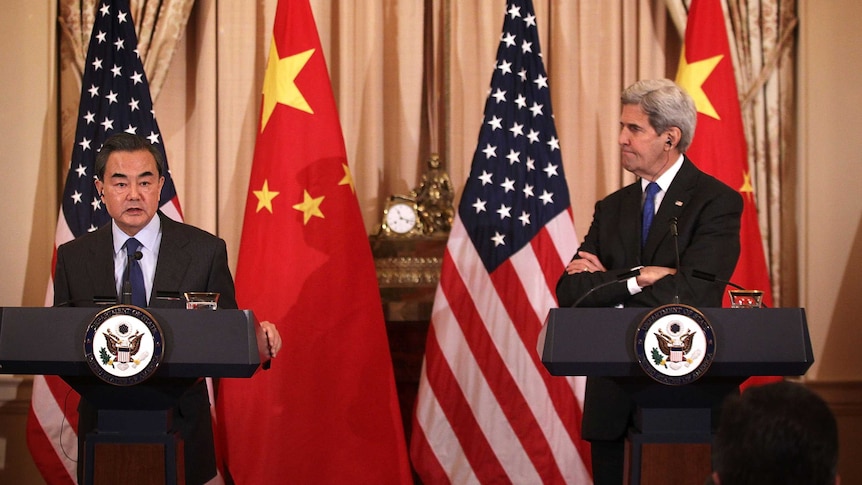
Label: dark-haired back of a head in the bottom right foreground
xmin=712 ymin=381 xmax=838 ymax=485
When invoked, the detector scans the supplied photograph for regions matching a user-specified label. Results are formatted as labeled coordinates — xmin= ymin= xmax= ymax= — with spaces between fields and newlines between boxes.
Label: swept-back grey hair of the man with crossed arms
xmin=620 ymin=79 xmax=697 ymax=153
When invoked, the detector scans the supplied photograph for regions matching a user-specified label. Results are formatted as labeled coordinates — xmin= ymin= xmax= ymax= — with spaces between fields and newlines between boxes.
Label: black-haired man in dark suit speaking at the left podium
xmin=54 ymin=133 xmax=281 ymax=484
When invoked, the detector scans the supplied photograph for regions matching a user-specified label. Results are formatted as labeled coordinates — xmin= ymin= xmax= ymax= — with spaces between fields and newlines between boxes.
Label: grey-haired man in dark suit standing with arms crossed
xmin=556 ymin=79 xmax=743 ymax=485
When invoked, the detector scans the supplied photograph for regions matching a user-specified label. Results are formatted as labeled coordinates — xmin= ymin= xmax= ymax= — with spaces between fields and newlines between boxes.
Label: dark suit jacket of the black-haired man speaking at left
xmin=54 ymin=212 xmax=237 ymax=484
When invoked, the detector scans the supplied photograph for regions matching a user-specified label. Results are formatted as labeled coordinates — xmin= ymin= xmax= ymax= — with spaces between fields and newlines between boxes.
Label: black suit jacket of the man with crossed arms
xmin=557 ymin=157 xmax=743 ymax=440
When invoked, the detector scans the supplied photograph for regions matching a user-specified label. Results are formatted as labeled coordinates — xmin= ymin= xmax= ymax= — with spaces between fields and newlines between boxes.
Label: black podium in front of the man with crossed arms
xmin=538 ymin=308 xmax=814 ymax=485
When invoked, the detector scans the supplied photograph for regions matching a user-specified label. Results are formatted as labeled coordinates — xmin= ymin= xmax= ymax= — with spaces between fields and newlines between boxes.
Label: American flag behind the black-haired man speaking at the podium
xmin=27 ymin=0 xmax=182 ymax=484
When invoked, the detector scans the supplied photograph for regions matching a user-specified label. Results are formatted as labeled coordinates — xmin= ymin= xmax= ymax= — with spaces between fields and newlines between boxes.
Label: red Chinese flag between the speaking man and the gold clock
xmin=217 ymin=0 xmax=411 ymax=484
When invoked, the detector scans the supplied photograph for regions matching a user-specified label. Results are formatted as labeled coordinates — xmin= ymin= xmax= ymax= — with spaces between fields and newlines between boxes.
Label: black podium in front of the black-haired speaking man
xmin=0 ymin=308 xmax=261 ymax=484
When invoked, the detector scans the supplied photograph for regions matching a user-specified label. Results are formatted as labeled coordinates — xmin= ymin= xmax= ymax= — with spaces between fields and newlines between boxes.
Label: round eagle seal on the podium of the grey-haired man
xmin=635 ymin=304 xmax=715 ymax=386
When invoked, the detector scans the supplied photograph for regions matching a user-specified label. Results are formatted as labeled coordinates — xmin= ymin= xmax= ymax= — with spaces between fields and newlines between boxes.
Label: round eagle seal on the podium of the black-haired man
xmin=84 ymin=305 xmax=165 ymax=386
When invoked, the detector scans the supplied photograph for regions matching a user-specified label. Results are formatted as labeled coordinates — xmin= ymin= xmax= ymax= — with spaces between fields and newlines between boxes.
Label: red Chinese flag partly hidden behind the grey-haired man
xmin=676 ymin=0 xmax=779 ymax=388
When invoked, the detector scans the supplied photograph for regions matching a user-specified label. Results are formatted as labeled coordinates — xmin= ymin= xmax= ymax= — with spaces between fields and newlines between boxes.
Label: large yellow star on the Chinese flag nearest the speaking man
xmin=260 ymin=39 xmax=314 ymax=131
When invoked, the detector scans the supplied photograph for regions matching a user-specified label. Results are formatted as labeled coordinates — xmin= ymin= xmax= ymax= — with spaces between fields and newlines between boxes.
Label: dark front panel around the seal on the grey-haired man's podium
xmin=538 ymin=308 xmax=814 ymax=377
